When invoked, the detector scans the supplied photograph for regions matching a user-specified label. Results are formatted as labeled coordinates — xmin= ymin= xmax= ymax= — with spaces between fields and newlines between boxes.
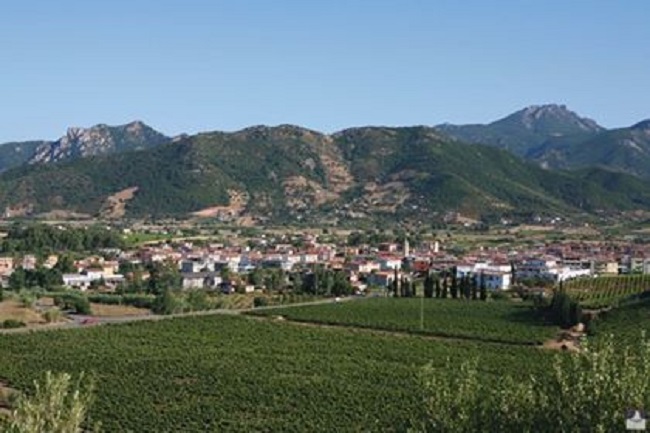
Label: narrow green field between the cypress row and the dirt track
xmin=248 ymin=298 xmax=558 ymax=344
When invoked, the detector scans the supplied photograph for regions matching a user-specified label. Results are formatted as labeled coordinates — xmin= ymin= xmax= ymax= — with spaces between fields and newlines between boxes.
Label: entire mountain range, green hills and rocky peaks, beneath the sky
xmin=0 ymin=105 xmax=650 ymax=223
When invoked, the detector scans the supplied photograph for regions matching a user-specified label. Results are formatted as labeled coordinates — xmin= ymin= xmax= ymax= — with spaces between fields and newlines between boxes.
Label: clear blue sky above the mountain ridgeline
xmin=0 ymin=0 xmax=650 ymax=142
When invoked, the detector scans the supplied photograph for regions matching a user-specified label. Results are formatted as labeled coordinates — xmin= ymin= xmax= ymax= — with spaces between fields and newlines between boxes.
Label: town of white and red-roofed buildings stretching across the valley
xmin=0 ymin=224 xmax=650 ymax=326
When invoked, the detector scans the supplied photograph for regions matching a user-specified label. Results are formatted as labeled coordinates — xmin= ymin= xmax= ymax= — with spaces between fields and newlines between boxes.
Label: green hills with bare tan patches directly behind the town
xmin=0 ymin=125 xmax=650 ymax=222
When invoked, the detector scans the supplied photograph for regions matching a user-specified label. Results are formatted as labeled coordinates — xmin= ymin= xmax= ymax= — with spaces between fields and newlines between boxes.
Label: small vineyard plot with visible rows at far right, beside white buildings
xmin=563 ymin=275 xmax=650 ymax=309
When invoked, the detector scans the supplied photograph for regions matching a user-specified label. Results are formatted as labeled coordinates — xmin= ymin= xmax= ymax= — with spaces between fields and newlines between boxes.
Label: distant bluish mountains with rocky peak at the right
xmin=438 ymin=104 xmax=650 ymax=179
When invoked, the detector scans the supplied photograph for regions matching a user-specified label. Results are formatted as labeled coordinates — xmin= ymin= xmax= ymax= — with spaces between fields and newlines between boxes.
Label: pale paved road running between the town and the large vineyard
xmin=0 ymin=296 xmax=365 ymax=334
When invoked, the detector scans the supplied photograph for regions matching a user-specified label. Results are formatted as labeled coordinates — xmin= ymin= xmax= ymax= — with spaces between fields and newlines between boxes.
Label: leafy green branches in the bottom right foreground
xmin=413 ymin=334 xmax=650 ymax=432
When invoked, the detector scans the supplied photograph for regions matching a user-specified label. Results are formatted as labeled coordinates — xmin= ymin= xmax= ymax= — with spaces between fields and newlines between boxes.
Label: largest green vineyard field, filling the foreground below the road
xmin=0 ymin=316 xmax=559 ymax=432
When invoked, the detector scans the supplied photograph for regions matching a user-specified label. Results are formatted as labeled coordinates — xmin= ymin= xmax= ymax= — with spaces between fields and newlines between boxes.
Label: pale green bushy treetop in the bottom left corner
xmin=0 ymin=371 xmax=98 ymax=433
